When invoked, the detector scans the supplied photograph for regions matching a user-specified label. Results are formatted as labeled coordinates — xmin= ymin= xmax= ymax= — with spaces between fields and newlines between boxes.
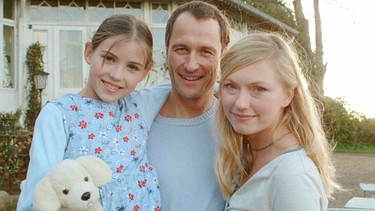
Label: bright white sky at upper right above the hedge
xmin=290 ymin=0 xmax=375 ymax=118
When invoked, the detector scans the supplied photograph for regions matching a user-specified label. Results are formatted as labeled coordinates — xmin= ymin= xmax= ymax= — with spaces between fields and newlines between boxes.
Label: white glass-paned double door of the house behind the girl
xmin=33 ymin=25 xmax=88 ymax=102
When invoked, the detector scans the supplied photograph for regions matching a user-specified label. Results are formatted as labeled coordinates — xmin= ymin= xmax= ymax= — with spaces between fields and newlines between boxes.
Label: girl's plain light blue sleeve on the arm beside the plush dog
xmin=17 ymin=103 xmax=67 ymax=211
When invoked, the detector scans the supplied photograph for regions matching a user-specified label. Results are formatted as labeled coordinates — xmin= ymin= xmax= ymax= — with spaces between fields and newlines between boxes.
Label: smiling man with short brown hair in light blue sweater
xmin=145 ymin=1 xmax=230 ymax=211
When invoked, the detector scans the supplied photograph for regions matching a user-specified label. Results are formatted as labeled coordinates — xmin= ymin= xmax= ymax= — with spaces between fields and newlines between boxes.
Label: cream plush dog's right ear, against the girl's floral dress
xmin=77 ymin=155 xmax=112 ymax=187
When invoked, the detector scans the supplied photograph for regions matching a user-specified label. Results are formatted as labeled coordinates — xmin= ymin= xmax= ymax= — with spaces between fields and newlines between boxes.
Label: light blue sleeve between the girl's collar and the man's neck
xmin=134 ymin=83 xmax=172 ymax=128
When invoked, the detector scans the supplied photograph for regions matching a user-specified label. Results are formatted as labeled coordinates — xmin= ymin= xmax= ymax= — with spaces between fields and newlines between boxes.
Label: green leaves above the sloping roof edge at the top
xmin=244 ymin=0 xmax=296 ymax=28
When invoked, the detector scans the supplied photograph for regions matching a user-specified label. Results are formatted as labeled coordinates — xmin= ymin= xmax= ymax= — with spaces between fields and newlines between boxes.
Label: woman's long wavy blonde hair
xmin=215 ymin=32 xmax=339 ymax=198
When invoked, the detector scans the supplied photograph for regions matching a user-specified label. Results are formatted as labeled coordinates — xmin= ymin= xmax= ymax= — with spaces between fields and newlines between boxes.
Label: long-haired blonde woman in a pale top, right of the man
xmin=215 ymin=32 xmax=339 ymax=211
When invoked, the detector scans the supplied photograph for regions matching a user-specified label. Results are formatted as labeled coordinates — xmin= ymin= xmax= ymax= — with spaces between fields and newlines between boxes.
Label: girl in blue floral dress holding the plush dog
xmin=17 ymin=15 xmax=161 ymax=210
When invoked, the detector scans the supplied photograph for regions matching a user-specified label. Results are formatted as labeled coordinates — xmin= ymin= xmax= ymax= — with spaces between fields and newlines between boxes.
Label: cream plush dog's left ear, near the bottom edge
xmin=33 ymin=177 xmax=61 ymax=211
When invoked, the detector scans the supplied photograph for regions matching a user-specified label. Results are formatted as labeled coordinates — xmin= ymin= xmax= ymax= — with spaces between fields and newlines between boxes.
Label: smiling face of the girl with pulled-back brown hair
xmin=80 ymin=35 xmax=151 ymax=102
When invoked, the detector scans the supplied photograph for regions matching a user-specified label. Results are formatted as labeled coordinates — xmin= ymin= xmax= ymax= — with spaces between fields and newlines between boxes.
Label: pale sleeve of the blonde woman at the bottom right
xmin=273 ymin=174 xmax=328 ymax=211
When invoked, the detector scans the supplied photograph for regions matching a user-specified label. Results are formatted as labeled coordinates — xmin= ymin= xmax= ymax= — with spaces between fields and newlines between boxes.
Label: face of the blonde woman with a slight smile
xmin=221 ymin=60 xmax=293 ymax=135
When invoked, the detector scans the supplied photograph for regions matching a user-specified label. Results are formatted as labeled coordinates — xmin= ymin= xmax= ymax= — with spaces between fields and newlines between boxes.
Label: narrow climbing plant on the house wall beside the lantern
xmin=24 ymin=42 xmax=43 ymax=129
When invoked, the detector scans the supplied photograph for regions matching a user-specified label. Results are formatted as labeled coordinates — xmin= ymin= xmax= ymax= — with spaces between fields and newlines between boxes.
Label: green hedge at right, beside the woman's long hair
xmin=323 ymin=97 xmax=375 ymax=151
